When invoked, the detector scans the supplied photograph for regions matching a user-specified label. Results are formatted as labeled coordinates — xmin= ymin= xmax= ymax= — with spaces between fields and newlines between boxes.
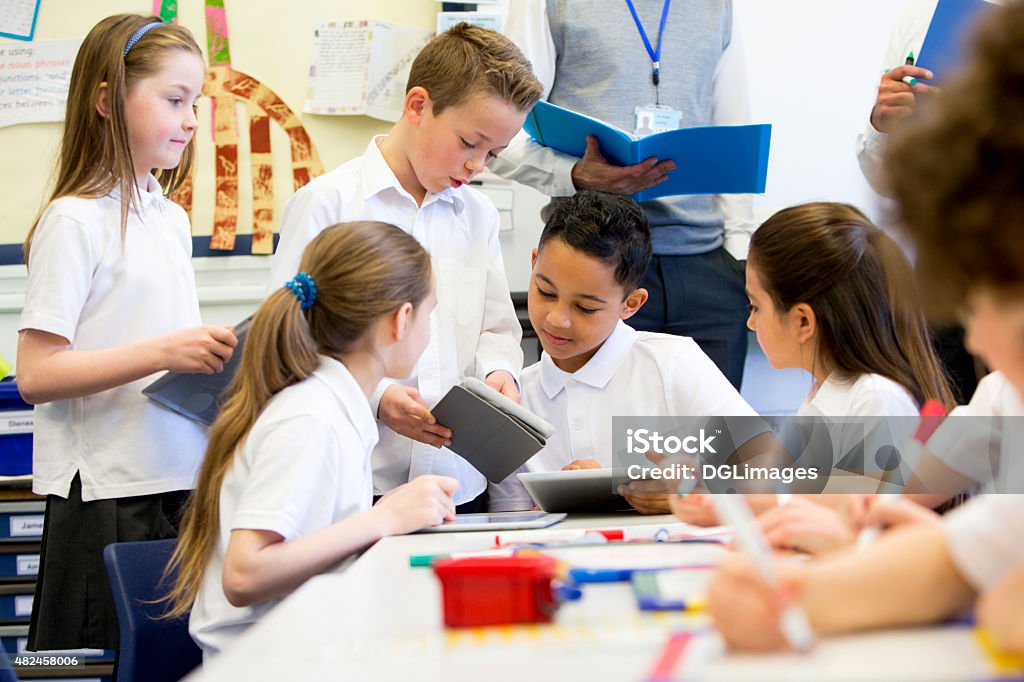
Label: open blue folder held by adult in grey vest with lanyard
xmin=523 ymin=100 xmax=771 ymax=202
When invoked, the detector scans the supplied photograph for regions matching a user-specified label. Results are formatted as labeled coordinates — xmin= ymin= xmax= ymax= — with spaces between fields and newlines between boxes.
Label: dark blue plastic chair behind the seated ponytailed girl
xmin=103 ymin=539 xmax=203 ymax=682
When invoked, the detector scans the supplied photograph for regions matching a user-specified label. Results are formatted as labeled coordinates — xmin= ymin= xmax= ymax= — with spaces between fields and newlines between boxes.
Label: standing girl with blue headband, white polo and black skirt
xmin=17 ymin=14 xmax=236 ymax=650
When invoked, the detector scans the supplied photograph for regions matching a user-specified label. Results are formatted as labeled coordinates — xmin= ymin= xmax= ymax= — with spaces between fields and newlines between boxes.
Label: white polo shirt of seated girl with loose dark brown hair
xmin=797 ymin=373 xmax=920 ymax=493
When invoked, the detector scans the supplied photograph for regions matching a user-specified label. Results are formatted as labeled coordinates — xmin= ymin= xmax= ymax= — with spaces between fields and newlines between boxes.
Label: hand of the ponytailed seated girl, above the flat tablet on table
xmin=374 ymin=474 xmax=459 ymax=536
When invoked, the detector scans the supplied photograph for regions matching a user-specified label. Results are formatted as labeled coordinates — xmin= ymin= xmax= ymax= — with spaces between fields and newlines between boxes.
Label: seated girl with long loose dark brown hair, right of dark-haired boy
xmin=746 ymin=203 xmax=953 ymax=553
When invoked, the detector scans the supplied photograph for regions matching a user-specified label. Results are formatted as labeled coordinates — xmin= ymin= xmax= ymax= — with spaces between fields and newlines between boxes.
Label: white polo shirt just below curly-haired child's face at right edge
xmin=928 ymin=372 xmax=1024 ymax=493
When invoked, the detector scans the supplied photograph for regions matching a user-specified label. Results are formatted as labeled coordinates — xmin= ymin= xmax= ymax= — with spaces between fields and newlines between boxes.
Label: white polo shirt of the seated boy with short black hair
xmin=490 ymin=321 xmax=767 ymax=511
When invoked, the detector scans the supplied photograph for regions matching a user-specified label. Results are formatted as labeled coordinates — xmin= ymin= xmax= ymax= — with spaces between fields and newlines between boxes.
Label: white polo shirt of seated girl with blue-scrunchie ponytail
xmin=188 ymin=355 xmax=377 ymax=657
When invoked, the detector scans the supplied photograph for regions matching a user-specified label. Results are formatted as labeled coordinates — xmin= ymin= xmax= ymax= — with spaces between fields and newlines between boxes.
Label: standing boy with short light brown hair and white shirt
xmin=269 ymin=24 xmax=541 ymax=503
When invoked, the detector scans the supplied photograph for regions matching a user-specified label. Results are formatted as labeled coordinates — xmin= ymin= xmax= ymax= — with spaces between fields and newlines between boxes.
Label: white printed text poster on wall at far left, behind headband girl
xmin=0 ymin=40 xmax=82 ymax=127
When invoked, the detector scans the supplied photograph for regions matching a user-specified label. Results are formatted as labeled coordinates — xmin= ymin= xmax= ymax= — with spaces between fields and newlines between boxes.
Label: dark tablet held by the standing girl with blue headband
xmin=142 ymin=317 xmax=251 ymax=426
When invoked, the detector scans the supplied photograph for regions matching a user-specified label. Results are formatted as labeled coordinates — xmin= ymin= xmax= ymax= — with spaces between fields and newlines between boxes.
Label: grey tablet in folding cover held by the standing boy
xmin=430 ymin=377 xmax=555 ymax=483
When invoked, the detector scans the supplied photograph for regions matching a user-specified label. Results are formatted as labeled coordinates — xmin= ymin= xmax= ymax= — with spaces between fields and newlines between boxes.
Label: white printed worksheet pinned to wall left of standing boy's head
xmin=302 ymin=19 xmax=433 ymax=122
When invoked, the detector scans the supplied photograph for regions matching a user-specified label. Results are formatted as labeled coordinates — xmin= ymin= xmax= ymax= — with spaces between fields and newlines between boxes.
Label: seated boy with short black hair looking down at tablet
xmin=490 ymin=190 xmax=757 ymax=513
